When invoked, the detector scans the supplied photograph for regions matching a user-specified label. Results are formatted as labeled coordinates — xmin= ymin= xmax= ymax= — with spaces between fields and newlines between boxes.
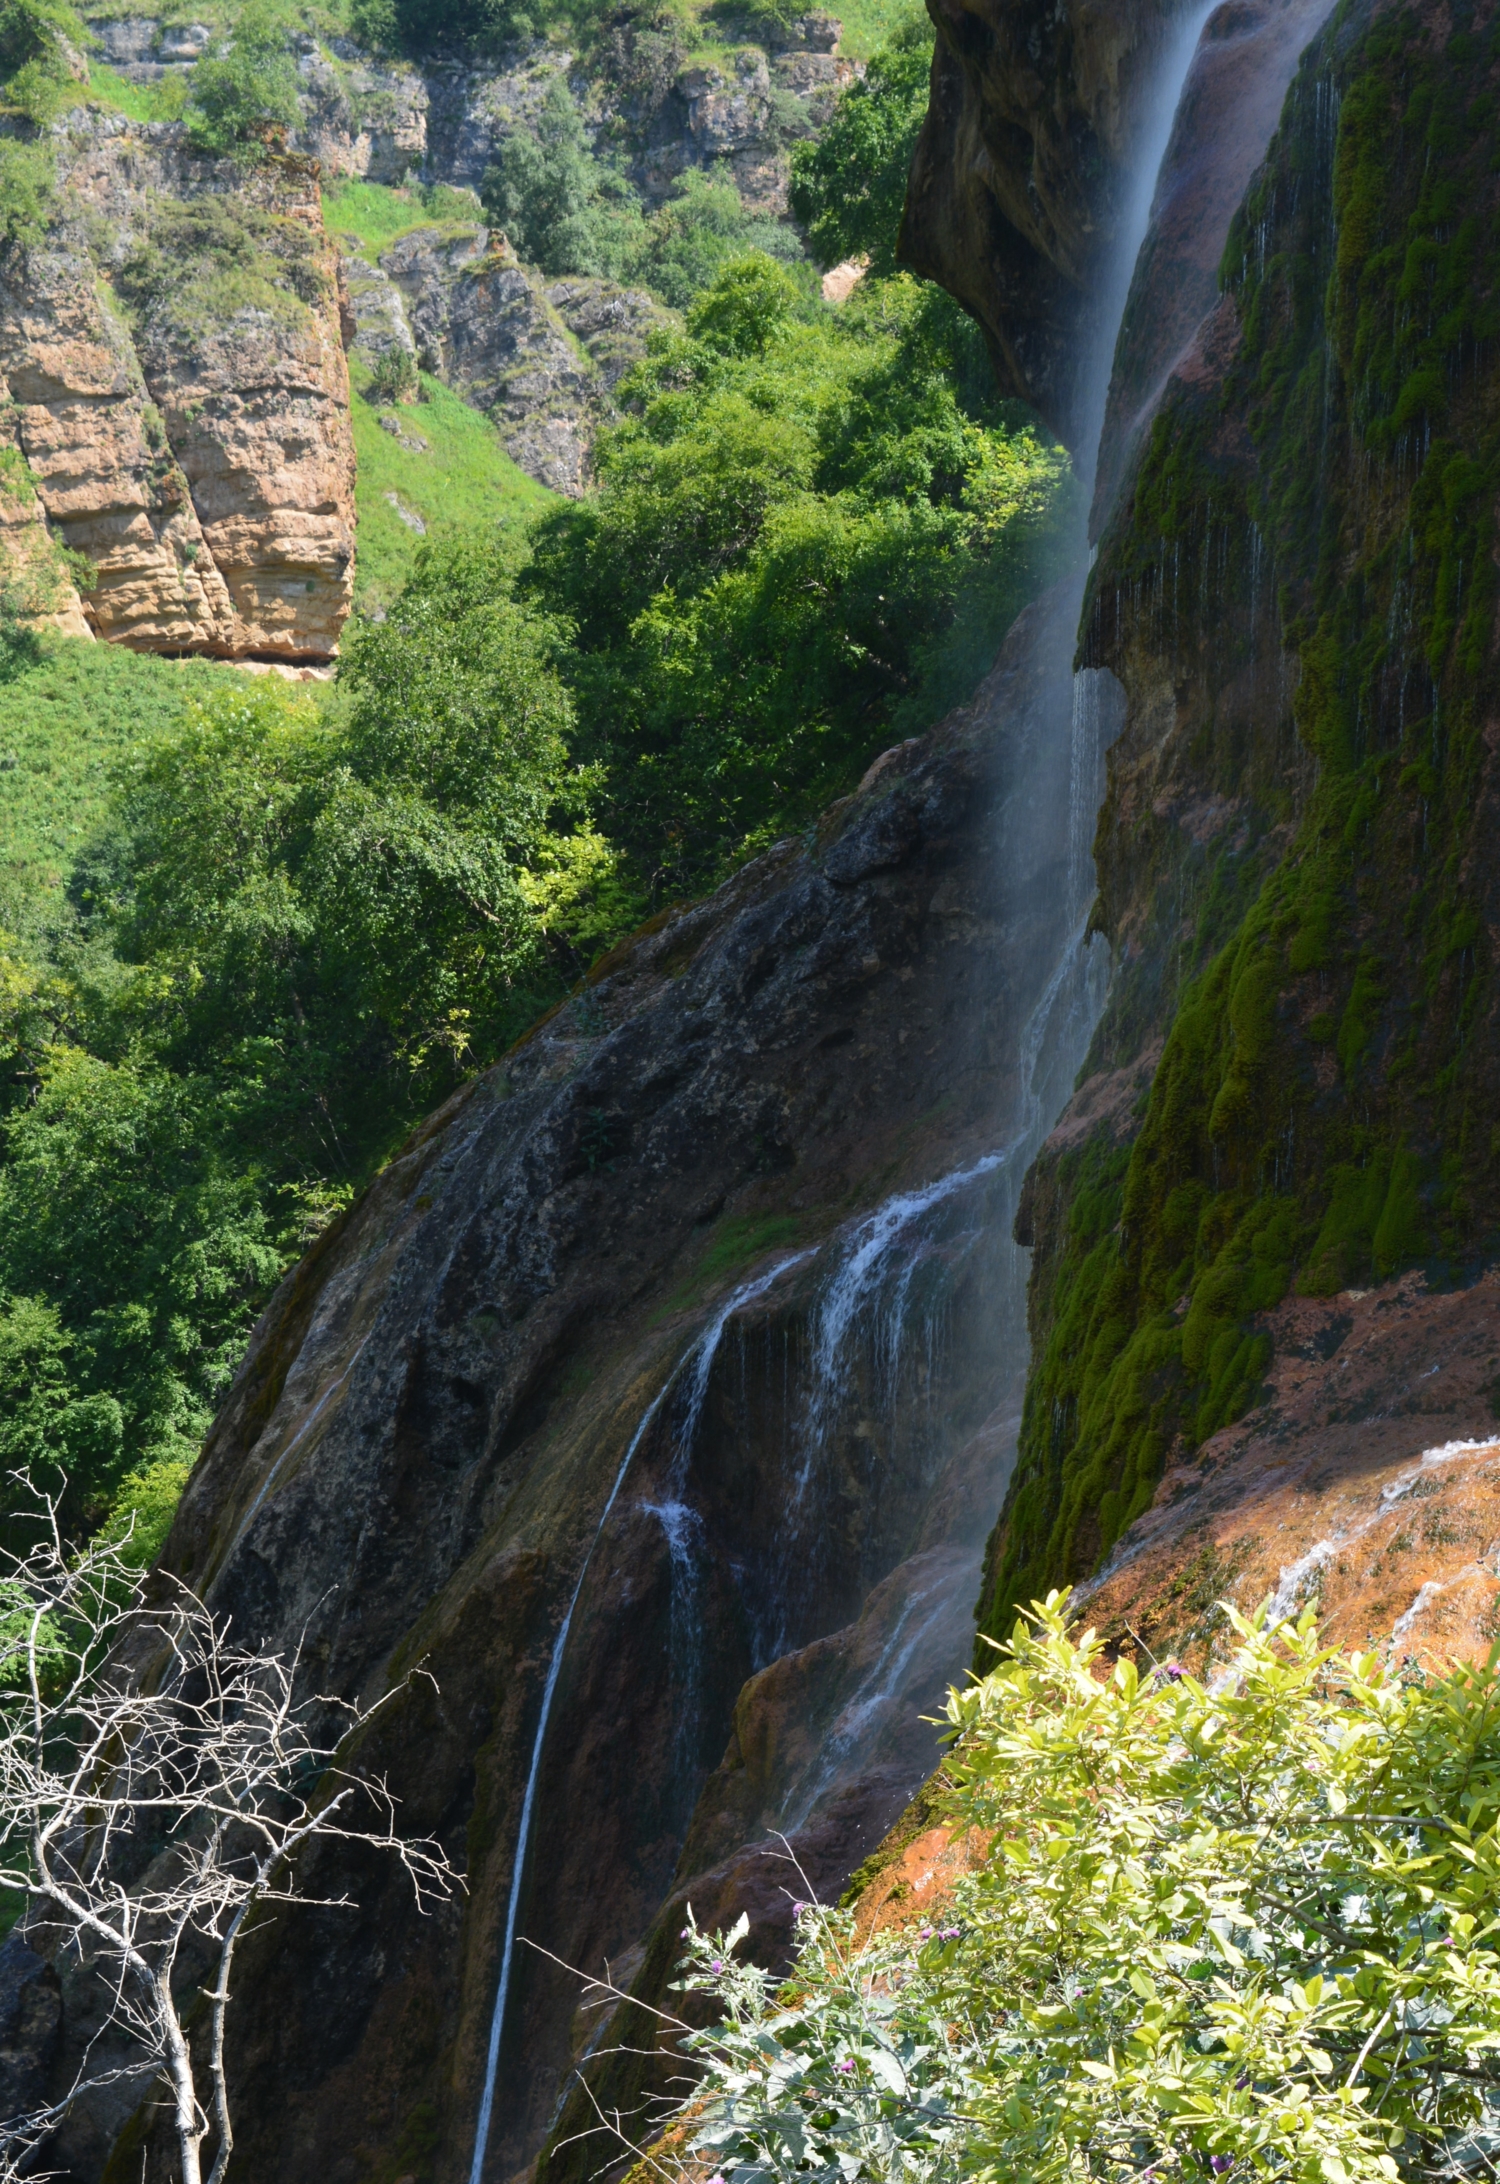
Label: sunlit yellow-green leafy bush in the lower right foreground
xmin=683 ymin=1594 xmax=1500 ymax=2184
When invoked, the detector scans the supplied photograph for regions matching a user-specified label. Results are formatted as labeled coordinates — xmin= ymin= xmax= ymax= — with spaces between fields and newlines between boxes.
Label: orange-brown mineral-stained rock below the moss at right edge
xmin=1081 ymin=1271 xmax=1500 ymax=1669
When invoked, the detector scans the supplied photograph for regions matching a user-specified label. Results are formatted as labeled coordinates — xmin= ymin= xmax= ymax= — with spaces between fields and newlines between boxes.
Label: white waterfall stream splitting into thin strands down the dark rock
xmin=469 ymin=12 xmax=1210 ymax=2184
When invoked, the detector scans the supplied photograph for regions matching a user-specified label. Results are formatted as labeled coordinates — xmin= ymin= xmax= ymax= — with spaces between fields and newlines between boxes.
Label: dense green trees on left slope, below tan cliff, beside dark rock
xmin=0 ymin=572 xmax=611 ymax=1544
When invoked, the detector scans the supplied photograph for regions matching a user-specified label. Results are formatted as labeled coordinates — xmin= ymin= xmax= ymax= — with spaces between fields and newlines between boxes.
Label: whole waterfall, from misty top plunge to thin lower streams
xmin=469 ymin=12 xmax=1210 ymax=2184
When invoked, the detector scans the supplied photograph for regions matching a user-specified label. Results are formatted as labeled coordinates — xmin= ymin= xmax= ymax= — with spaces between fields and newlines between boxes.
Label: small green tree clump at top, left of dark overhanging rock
xmin=790 ymin=15 xmax=932 ymax=275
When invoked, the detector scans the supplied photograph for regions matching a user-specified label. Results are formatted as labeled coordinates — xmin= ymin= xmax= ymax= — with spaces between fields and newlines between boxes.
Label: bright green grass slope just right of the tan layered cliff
xmin=349 ymin=356 xmax=555 ymax=614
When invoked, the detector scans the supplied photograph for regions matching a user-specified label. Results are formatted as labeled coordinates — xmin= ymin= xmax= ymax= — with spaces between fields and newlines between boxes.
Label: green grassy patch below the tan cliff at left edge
xmin=0 ymin=636 xmax=236 ymax=895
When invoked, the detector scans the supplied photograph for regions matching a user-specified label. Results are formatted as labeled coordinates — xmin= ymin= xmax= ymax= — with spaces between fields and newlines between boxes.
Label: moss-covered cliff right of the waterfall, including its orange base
xmin=985 ymin=9 xmax=1500 ymax=1647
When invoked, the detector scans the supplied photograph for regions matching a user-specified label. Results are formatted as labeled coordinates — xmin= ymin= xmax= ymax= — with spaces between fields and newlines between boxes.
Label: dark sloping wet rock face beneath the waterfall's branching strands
xmin=46 ymin=590 xmax=1091 ymax=2184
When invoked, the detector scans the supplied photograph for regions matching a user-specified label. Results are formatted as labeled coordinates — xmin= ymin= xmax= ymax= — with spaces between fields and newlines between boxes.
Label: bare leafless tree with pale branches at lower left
xmin=0 ymin=1498 xmax=459 ymax=2184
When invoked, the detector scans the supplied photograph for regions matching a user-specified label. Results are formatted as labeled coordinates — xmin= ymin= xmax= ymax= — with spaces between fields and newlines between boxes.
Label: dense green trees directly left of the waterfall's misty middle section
xmin=522 ymin=258 xmax=1066 ymax=893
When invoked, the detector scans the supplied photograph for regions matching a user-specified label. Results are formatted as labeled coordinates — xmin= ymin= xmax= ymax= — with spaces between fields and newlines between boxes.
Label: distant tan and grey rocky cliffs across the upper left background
xmin=0 ymin=11 xmax=856 ymax=646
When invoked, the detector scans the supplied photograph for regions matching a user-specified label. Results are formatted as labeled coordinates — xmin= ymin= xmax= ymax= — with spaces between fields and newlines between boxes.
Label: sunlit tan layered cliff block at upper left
xmin=0 ymin=118 xmax=354 ymax=660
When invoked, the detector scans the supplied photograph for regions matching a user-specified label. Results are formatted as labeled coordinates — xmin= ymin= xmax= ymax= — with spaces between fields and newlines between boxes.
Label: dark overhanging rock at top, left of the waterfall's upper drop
xmin=900 ymin=0 xmax=1186 ymax=439
